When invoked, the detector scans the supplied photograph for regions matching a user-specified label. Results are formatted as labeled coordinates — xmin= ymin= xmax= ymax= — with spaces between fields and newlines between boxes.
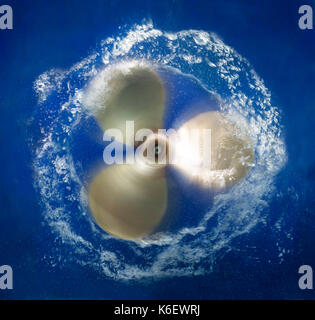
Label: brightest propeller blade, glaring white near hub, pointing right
xmin=169 ymin=111 xmax=254 ymax=190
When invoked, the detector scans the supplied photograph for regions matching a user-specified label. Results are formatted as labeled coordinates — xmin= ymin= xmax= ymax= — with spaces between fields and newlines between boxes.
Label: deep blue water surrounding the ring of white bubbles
xmin=0 ymin=0 xmax=315 ymax=299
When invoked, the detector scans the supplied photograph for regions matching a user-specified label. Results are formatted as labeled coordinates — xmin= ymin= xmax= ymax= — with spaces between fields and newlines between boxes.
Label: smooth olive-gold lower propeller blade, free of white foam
xmin=89 ymin=164 xmax=167 ymax=240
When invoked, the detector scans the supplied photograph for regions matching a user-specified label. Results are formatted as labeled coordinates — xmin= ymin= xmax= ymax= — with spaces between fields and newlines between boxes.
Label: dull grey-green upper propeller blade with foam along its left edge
xmin=96 ymin=65 xmax=165 ymax=145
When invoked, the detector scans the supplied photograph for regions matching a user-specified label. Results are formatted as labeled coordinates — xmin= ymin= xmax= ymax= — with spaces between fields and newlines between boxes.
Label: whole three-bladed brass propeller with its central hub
xmin=89 ymin=66 xmax=254 ymax=240
